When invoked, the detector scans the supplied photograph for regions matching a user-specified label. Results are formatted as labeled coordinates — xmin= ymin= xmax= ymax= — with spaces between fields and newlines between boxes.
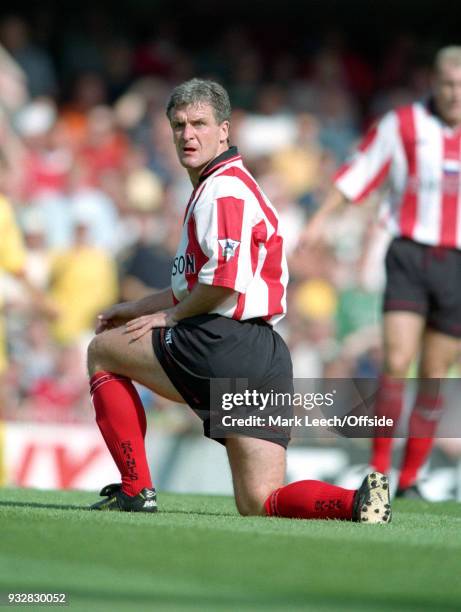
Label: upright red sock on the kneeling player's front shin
xmin=90 ymin=372 xmax=152 ymax=495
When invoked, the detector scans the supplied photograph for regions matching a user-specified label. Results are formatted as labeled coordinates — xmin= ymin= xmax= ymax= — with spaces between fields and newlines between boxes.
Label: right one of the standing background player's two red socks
xmin=399 ymin=389 xmax=443 ymax=489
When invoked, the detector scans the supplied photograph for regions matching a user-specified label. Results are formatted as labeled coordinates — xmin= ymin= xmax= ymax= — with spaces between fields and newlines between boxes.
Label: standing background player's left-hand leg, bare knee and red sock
xmin=370 ymin=311 xmax=425 ymax=473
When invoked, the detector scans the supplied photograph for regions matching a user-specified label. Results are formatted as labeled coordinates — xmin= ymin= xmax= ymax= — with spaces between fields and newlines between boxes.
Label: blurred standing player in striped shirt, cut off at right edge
xmin=301 ymin=46 xmax=461 ymax=496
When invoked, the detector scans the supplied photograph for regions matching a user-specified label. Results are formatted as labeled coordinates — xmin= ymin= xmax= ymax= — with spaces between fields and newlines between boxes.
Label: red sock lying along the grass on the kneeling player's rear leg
xmin=264 ymin=480 xmax=356 ymax=520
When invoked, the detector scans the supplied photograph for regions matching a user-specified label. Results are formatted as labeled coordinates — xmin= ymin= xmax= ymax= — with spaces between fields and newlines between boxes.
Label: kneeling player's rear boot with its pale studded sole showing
xmin=352 ymin=472 xmax=392 ymax=523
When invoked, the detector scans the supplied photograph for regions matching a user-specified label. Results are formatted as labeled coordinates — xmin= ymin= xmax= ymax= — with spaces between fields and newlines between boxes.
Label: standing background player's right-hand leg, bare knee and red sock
xmin=398 ymin=329 xmax=460 ymax=493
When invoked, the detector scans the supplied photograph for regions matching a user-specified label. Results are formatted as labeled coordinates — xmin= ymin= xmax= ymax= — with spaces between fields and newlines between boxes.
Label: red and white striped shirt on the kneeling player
xmin=171 ymin=147 xmax=288 ymax=325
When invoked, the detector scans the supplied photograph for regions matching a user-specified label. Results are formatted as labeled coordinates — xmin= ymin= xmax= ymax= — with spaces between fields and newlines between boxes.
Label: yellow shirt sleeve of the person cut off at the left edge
xmin=0 ymin=197 xmax=26 ymax=274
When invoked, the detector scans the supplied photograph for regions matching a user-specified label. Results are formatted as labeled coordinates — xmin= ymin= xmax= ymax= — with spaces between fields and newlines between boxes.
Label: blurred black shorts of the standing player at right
xmin=383 ymin=238 xmax=461 ymax=338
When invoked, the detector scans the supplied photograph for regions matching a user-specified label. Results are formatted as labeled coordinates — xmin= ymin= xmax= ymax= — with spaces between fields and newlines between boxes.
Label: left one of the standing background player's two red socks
xmin=370 ymin=374 xmax=405 ymax=474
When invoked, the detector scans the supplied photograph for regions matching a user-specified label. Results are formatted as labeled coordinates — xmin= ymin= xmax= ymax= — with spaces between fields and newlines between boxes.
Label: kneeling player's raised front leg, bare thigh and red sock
xmin=88 ymin=327 xmax=184 ymax=496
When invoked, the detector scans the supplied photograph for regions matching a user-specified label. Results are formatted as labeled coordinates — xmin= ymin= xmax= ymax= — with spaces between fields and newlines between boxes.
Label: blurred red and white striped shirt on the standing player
xmin=335 ymin=102 xmax=461 ymax=249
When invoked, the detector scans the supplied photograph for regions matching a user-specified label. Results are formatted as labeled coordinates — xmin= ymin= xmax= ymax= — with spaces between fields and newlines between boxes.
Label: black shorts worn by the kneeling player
xmin=152 ymin=314 xmax=293 ymax=448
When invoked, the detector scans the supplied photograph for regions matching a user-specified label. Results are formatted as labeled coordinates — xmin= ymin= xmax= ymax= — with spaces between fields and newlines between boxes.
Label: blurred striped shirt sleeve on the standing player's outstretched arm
xmin=334 ymin=112 xmax=397 ymax=202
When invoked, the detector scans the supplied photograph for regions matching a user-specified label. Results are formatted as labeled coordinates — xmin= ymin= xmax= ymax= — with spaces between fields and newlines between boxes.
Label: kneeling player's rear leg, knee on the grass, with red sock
xmin=226 ymin=437 xmax=355 ymax=520
